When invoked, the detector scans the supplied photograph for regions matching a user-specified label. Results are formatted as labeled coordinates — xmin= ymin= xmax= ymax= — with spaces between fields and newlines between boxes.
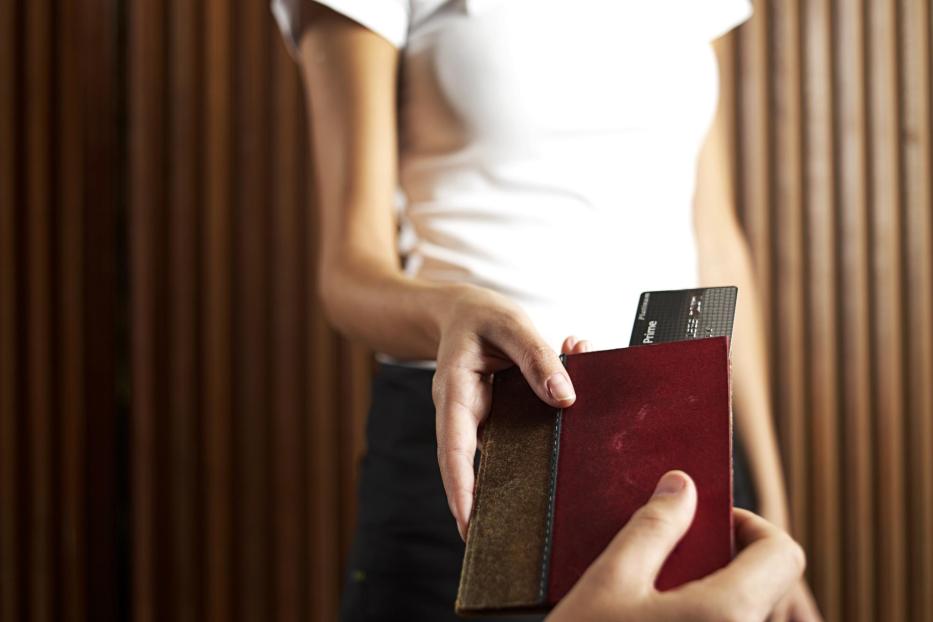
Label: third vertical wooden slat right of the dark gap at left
xmin=201 ymin=0 xmax=233 ymax=622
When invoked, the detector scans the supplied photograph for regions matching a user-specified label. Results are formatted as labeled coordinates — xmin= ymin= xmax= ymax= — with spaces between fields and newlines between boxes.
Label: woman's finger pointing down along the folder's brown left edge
xmin=432 ymin=365 xmax=490 ymax=538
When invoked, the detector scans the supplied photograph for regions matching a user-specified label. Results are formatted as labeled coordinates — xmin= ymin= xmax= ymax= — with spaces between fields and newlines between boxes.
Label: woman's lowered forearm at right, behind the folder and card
xmin=700 ymin=230 xmax=788 ymax=529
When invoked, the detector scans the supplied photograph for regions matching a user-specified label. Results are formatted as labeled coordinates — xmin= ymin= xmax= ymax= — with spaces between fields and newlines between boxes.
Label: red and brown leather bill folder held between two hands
xmin=456 ymin=337 xmax=734 ymax=614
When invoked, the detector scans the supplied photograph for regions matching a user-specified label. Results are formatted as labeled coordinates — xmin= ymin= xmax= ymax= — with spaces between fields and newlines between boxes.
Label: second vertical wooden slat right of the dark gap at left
xmin=167 ymin=0 xmax=204 ymax=622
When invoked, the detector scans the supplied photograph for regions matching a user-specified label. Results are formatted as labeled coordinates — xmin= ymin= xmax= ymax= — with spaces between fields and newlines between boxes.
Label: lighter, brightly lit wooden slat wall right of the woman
xmin=724 ymin=0 xmax=933 ymax=621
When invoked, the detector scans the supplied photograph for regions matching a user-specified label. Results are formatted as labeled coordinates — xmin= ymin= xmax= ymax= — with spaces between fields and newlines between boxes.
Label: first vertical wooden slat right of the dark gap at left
xmin=128 ymin=1 xmax=165 ymax=622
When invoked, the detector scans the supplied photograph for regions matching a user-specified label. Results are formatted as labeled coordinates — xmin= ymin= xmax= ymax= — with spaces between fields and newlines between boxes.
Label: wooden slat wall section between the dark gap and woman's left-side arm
xmin=126 ymin=0 xmax=372 ymax=621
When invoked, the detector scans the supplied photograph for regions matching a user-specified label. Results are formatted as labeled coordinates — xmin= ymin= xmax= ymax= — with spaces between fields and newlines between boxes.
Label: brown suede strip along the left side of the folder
xmin=456 ymin=368 xmax=557 ymax=613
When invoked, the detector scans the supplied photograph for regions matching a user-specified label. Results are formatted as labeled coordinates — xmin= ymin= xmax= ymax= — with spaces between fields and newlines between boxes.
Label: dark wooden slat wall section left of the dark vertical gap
xmin=0 ymin=0 xmax=121 ymax=621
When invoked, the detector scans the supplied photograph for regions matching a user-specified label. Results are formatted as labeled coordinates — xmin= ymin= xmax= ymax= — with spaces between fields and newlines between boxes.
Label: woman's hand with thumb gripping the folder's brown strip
xmin=433 ymin=286 xmax=589 ymax=538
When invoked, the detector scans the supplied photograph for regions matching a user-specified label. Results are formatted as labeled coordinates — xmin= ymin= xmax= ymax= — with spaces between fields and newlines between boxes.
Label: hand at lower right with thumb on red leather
xmin=549 ymin=471 xmax=805 ymax=622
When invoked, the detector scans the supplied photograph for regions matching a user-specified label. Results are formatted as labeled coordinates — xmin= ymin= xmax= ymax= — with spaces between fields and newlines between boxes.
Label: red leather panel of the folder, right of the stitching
xmin=548 ymin=337 xmax=734 ymax=605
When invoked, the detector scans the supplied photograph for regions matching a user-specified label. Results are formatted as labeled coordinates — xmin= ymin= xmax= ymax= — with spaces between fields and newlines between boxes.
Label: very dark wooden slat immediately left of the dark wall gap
xmin=77 ymin=0 xmax=118 ymax=622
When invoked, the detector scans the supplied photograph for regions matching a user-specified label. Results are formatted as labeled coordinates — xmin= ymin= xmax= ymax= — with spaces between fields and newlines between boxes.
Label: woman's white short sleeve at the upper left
xmin=272 ymin=0 xmax=411 ymax=59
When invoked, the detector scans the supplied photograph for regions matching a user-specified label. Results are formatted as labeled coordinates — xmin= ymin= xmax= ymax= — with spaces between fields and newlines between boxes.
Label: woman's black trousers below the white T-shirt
xmin=341 ymin=364 xmax=752 ymax=622
